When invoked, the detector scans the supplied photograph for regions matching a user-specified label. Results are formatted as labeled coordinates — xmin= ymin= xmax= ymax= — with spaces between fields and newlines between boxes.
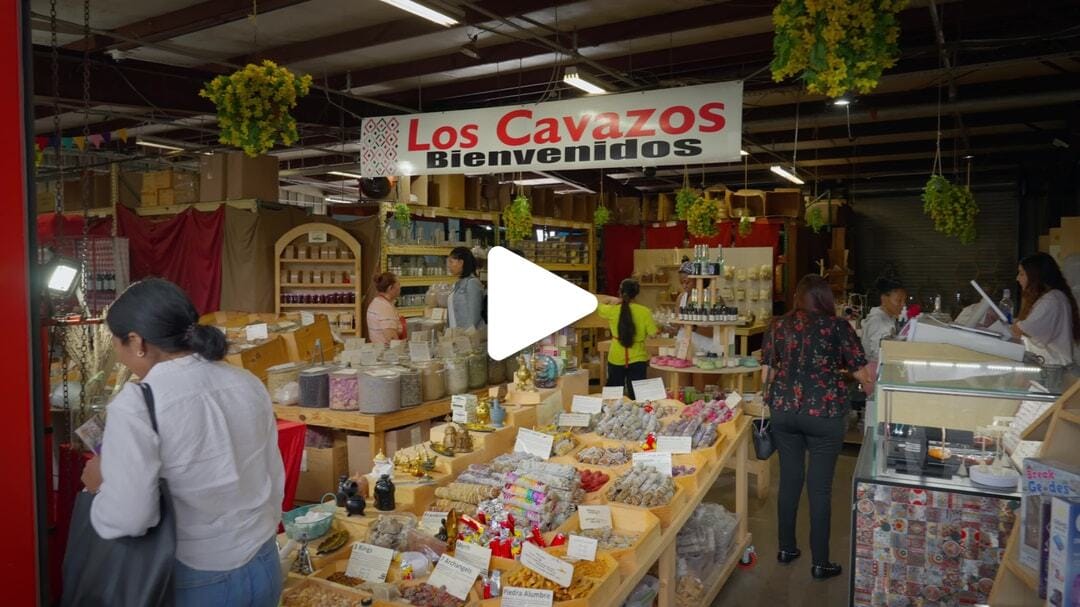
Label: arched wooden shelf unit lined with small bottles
xmin=274 ymin=224 xmax=364 ymax=335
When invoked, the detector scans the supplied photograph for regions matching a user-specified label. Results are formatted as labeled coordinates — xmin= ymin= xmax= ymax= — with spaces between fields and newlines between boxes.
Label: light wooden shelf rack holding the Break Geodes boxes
xmin=989 ymin=381 xmax=1080 ymax=607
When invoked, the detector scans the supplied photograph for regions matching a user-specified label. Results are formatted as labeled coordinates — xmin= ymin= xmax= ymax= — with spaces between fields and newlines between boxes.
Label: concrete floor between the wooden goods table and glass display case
xmin=705 ymin=448 xmax=859 ymax=607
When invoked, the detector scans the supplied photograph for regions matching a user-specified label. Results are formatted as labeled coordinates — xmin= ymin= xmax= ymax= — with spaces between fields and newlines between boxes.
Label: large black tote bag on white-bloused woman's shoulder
xmin=60 ymin=383 xmax=176 ymax=607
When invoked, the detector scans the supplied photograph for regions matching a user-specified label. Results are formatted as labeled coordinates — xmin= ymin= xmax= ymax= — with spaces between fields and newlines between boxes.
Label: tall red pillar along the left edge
xmin=0 ymin=0 xmax=44 ymax=605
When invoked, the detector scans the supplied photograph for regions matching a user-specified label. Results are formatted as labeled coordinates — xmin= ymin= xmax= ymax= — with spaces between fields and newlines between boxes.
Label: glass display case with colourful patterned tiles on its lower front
xmin=850 ymin=356 xmax=1069 ymax=607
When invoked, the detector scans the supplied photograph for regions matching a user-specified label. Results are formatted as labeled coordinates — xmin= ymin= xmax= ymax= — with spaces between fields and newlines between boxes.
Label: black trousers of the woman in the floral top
xmin=770 ymin=412 xmax=847 ymax=565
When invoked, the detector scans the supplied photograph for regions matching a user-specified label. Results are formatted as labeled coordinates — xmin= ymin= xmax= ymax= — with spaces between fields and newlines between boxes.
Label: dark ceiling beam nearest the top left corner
xmin=65 ymin=0 xmax=308 ymax=53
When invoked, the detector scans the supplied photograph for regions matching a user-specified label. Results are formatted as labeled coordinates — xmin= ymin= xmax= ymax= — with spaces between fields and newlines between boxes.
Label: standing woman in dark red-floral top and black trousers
xmin=761 ymin=274 xmax=873 ymax=579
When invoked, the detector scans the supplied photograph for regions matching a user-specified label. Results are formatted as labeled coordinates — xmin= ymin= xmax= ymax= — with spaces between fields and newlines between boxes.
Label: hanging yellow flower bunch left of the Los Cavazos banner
xmin=199 ymin=60 xmax=311 ymax=157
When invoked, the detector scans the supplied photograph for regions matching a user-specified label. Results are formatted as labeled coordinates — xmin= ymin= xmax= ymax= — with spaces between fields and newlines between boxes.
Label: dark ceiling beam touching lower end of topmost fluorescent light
xmin=213 ymin=0 xmax=575 ymax=69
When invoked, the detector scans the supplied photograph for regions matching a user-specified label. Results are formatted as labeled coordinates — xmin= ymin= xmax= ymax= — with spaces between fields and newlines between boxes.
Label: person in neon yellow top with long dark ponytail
xmin=596 ymin=279 xmax=657 ymax=399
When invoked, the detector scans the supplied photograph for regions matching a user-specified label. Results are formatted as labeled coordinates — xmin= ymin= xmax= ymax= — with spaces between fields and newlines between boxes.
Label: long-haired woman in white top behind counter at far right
xmin=1012 ymin=253 xmax=1080 ymax=366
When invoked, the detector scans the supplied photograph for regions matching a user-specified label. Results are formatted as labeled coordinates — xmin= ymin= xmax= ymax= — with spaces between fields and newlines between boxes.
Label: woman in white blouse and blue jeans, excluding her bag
xmin=83 ymin=280 xmax=285 ymax=607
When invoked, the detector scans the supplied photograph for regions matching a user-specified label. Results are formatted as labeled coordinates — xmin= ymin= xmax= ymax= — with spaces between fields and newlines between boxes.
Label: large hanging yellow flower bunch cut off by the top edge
xmin=770 ymin=0 xmax=907 ymax=97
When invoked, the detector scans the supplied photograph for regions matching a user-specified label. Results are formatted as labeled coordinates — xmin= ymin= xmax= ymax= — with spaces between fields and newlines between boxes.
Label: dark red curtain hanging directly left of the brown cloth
xmin=117 ymin=206 xmax=225 ymax=314
